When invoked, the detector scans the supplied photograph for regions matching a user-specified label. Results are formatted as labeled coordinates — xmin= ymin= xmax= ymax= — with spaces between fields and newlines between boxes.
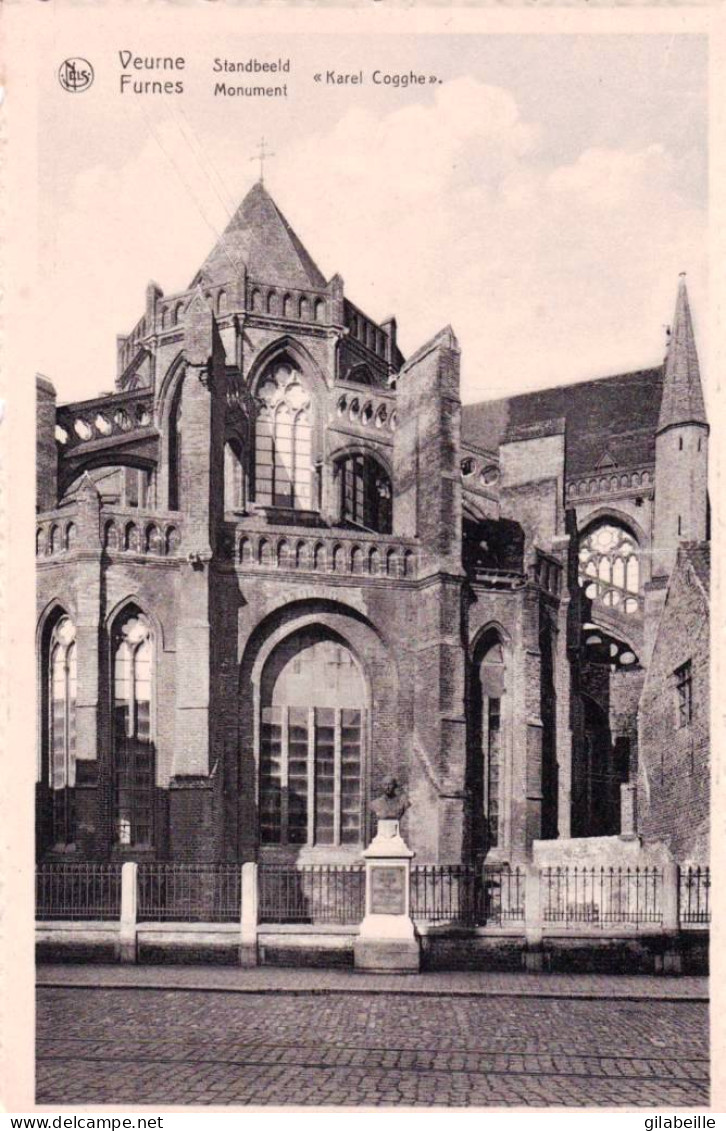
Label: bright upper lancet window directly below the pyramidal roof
xmin=254 ymin=360 xmax=312 ymax=510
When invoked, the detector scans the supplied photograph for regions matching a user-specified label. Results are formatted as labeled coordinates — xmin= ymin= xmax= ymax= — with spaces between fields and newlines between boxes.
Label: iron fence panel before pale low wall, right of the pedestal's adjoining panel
xmin=542 ymin=866 xmax=663 ymax=926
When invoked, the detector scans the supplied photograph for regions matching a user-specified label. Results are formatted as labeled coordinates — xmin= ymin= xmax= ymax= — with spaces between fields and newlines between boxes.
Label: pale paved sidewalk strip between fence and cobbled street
xmin=37 ymin=964 xmax=708 ymax=1002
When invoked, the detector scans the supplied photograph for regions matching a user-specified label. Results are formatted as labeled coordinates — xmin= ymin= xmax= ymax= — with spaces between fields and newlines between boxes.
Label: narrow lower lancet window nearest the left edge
xmin=49 ymin=616 xmax=78 ymax=845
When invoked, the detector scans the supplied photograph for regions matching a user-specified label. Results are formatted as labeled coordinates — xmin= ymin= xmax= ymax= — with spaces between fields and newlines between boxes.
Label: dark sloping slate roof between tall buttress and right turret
xmin=461 ymin=365 xmax=664 ymax=478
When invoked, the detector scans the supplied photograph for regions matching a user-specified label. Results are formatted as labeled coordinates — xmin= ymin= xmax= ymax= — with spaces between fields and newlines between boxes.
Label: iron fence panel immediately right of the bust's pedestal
xmin=410 ymin=864 xmax=525 ymax=926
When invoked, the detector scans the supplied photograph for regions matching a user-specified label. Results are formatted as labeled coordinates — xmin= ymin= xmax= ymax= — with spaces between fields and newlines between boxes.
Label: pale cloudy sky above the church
xmin=33 ymin=31 xmax=708 ymax=402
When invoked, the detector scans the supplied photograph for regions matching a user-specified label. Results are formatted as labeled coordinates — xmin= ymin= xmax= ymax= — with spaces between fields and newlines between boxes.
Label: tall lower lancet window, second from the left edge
xmin=112 ymin=610 xmax=155 ymax=847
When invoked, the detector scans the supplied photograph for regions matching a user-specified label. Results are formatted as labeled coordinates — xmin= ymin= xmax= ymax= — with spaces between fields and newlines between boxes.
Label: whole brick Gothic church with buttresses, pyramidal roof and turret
xmin=36 ymin=184 xmax=708 ymax=863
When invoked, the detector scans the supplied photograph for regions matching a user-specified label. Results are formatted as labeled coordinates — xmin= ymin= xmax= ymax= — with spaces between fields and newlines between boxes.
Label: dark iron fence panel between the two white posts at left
xmin=137 ymin=863 xmax=242 ymax=923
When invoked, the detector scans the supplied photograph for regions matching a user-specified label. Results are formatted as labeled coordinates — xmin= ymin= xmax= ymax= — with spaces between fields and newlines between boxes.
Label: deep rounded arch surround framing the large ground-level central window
xmin=235 ymin=597 xmax=401 ymax=860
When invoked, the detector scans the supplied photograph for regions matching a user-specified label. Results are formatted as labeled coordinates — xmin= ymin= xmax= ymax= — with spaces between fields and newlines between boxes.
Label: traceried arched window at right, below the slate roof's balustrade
xmin=578 ymin=521 xmax=640 ymax=615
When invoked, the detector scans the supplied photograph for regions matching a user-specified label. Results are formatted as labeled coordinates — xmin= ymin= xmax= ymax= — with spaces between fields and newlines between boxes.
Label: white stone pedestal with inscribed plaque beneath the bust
xmin=354 ymin=820 xmax=421 ymax=974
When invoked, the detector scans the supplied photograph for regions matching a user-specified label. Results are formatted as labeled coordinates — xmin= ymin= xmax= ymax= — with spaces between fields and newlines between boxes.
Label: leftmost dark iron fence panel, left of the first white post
xmin=35 ymin=863 xmax=121 ymax=921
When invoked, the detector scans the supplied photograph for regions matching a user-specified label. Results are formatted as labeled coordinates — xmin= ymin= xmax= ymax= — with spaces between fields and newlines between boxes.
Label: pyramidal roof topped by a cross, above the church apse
xmin=192 ymin=182 xmax=326 ymax=291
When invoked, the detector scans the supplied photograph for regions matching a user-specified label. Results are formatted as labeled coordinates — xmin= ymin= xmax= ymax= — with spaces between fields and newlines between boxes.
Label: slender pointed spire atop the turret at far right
xmin=658 ymin=275 xmax=707 ymax=432
